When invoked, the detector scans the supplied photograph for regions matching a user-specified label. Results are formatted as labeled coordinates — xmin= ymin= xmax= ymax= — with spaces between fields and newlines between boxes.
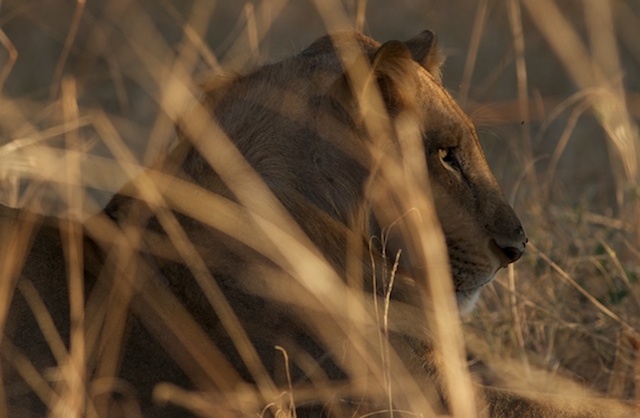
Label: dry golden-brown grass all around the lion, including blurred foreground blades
xmin=0 ymin=0 xmax=640 ymax=417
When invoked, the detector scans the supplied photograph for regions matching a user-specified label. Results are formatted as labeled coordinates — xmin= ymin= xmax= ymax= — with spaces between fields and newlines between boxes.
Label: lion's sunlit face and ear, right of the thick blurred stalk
xmin=358 ymin=31 xmax=527 ymax=310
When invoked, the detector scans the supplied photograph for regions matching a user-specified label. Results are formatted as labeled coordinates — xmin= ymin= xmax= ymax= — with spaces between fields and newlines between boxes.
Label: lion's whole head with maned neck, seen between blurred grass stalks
xmin=170 ymin=31 xmax=526 ymax=309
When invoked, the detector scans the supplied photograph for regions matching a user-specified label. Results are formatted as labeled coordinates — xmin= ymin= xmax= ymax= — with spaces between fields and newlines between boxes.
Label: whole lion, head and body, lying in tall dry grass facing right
xmin=2 ymin=31 xmax=632 ymax=417
